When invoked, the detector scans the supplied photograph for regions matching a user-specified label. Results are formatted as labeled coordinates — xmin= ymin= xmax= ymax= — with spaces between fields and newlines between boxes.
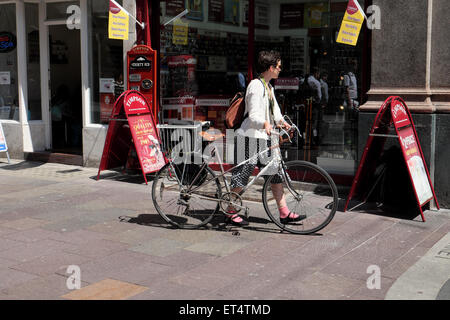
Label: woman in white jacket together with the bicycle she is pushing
xmin=152 ymin=51 xmax=338 ymax=234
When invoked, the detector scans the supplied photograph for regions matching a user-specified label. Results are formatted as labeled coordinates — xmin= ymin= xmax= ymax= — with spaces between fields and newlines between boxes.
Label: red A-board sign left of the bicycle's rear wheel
xmin=97 ymin=90 xmax=166 ymax=183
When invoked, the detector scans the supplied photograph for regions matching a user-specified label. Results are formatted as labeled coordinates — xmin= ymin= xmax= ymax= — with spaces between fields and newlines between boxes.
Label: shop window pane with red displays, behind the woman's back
xmin=160 ymin=0 xmax=248 ymax=130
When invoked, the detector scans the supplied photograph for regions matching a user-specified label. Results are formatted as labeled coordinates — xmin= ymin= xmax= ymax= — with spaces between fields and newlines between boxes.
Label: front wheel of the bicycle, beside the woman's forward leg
xmin=263 ymin=160 xmax=338 ymax=234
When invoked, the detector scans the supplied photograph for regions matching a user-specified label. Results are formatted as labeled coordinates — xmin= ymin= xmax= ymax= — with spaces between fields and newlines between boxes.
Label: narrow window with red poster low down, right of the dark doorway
xmin=88 ymin=0 xmax=124 ymax=124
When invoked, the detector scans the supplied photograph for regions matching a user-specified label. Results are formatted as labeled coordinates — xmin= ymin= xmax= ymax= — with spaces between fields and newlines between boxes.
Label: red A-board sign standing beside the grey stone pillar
xmin=344 ymin=96 xmax=439 ymax=221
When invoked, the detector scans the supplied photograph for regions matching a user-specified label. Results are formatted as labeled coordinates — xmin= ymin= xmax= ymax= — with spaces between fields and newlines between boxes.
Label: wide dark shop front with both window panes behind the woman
xmin=156 ymin=0 xmax=370 ymax=183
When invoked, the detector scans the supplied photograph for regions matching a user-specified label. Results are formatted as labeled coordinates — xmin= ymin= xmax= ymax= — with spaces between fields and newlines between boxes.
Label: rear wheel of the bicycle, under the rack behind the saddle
xmin=152 ymin=163 xmax=221 ymax=229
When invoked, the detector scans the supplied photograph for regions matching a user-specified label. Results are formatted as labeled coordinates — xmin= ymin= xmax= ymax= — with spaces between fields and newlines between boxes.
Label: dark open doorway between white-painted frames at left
xmin=48 ymin=25 xmax=82 ymax=155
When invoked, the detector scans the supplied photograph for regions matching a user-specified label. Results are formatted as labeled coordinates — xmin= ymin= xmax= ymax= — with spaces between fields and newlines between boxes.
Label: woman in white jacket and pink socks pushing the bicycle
xmin=226 ymin=51 xmax=306 ymax=226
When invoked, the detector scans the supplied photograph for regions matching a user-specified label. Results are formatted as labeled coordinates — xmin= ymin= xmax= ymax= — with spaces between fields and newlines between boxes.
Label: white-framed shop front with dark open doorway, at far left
xmin=0 ymin=0 xmax=135 ymax=166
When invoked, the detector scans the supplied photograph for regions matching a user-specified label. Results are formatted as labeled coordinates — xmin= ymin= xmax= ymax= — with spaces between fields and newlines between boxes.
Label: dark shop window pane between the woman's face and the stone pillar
xmin=254 ymin=1 xmax=366 ymax=175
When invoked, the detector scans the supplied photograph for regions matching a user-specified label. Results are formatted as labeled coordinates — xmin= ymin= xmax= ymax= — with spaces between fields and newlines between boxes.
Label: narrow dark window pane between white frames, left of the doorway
xmin=25 ymin=3 xmax=42 ymax=120
